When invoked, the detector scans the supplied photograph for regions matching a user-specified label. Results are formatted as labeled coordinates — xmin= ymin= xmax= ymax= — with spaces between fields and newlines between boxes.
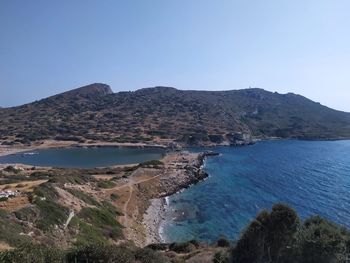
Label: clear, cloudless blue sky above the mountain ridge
xmin=0 ymin=0 xmax=350 ymax=112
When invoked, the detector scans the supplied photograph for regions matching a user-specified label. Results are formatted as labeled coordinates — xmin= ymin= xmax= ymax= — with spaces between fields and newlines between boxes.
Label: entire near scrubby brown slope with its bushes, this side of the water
xmin=0 ymin=155 xmax=350 ymax=263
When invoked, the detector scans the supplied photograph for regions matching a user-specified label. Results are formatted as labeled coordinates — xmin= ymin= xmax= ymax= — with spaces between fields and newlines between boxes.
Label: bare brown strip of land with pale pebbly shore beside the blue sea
xmin=106 ymin=152 xmax=215 ymax=247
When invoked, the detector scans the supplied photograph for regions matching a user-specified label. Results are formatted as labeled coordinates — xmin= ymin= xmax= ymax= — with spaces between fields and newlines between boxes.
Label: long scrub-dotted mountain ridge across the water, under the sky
xmin=0 ymin=83 xmax=350 ymax=145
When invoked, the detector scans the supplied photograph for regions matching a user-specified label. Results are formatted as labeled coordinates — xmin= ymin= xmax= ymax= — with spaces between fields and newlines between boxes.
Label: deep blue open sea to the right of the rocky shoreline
xmin=161 ymin=141 xmax=350 ymax=244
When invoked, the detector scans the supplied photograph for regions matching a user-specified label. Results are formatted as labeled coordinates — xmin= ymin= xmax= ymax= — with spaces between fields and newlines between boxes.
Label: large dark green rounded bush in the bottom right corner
xmin=232 ymin=204 xmax=350 ymax=263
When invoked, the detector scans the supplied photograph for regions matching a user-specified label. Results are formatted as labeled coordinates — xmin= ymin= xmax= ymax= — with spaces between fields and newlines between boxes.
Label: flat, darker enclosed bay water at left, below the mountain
xmin=0 ymin=147 xmax=164 ymax=168
